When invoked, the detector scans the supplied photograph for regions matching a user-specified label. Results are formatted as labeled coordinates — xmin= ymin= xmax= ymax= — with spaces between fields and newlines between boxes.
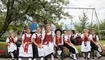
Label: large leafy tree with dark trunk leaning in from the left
xmin=0 ymin=0 xmax=69 ymax=37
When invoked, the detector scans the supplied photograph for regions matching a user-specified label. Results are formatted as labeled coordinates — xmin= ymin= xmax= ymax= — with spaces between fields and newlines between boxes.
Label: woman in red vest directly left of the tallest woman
xmin=32 ymin=27 xmax=44 ymax=60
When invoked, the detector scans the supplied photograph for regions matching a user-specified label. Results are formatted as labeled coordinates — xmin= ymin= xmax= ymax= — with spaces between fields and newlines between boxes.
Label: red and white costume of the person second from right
xmin=81 ymin=34 xmax=91 ymax=52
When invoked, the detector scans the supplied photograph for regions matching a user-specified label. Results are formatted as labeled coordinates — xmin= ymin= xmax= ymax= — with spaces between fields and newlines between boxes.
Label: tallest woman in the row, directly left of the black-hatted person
xmin=42 ymin=24 xmax=54 ymax=60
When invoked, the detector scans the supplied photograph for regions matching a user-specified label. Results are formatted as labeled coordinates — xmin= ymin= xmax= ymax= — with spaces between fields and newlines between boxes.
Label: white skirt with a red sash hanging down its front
xmin=19 ymin=44 xmax=33 ymax=58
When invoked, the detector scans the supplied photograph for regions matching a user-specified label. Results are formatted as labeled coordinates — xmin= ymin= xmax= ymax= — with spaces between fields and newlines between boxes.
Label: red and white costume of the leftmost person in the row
xmin=6 ymin=37 xmax=17 ymax=53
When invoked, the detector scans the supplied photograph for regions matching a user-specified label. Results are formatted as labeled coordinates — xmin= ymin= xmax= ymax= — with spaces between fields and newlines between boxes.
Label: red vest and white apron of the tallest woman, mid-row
xmin=42 ymin=31 xmax=54 ymax=55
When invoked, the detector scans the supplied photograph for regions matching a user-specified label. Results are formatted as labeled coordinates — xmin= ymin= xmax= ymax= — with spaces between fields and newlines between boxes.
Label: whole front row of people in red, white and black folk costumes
xmin=6 ymin=21 xmax=102 ymax=60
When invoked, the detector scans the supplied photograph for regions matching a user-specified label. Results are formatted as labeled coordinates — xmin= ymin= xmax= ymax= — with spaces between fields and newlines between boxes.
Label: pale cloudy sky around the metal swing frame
xmin=60 ymin=0 xmax=105 ymax=29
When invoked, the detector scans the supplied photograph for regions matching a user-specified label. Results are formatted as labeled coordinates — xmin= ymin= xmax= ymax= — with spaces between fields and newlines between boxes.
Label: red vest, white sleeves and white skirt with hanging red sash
xmin=19 ymin=33 xmax=33 ymax=57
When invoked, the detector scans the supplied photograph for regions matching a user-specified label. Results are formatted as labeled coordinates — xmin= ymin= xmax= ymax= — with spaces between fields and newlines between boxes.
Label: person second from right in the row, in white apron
xmin=81 ymin=29 xmax=91 ymax=60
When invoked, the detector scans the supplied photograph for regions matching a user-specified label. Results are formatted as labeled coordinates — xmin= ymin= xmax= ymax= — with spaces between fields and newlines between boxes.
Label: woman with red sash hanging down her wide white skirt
xmin=19 ymin=28 xmax=33 ymax=60
